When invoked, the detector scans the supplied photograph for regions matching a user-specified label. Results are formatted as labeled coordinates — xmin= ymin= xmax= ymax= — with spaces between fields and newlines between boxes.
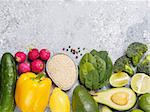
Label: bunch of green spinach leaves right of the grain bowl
xmin=79 ymin=50 xmax=113 ymax=90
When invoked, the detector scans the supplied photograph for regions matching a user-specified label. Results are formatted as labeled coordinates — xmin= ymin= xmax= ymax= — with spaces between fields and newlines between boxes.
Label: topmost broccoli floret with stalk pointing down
xmin=126 ymin=42 xmax=148 ymax=66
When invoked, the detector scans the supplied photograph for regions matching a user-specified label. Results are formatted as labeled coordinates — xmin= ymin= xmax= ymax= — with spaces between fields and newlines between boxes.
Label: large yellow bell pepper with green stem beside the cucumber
xmin=15 ymin=72 xmax=52 ymax=112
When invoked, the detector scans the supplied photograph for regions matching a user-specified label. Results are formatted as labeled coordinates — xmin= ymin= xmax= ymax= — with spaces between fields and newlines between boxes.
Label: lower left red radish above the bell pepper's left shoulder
xmin=18 ymin=62 xmax=30 ymax=74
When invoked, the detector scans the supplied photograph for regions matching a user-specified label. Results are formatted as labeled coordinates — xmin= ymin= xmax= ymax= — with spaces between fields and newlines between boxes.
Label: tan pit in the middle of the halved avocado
xmin=111 ymin=92 xmax=129 ymax=106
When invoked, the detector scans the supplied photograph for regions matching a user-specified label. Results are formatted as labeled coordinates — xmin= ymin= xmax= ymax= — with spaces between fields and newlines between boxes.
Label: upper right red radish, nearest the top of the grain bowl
xmin=40 ymin=49 xmax=50 ymax=61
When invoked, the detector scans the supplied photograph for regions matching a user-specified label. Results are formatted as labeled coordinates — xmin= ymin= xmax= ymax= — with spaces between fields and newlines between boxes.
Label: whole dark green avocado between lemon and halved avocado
xmin=72 ymin=85 xmax=99 ymax=112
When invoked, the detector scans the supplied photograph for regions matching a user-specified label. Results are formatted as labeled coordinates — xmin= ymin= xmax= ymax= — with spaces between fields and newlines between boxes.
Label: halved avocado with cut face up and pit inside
xmin=93 ymin=87 xmax=136 ymax=111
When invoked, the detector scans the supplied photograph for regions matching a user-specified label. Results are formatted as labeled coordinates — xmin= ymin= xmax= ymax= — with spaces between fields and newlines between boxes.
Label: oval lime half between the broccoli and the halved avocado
xmin=109 ymin=72 xmax=130 ymax=87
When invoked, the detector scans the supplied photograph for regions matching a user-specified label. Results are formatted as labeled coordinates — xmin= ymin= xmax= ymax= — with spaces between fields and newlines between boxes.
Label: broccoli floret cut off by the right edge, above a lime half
xmin=137 ymin=54 xmax=150 ymax=75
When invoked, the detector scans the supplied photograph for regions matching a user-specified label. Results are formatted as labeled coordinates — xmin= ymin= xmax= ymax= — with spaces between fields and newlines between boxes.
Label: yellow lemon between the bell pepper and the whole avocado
xmin=49 ymin=88 xmax=70 ymax=112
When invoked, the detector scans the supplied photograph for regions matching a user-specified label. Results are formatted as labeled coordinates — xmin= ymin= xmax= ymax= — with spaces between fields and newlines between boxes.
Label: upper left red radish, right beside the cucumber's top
xmin=15 ymin=51 xmax=26 ymax=63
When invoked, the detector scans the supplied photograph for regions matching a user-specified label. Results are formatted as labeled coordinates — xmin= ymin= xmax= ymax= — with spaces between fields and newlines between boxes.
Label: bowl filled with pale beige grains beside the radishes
xmin=46 ymin=54 xmax=78 ymax=90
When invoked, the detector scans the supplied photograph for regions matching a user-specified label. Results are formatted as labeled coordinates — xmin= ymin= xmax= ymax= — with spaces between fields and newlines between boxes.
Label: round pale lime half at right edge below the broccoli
xmin=131 ymin=73 xmax=150 ymax=94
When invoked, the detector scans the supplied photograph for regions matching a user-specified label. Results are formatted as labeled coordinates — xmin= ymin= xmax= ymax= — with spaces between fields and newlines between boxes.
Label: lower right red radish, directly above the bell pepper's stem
xmin=31 ymin=59 xmax=44 ymax=73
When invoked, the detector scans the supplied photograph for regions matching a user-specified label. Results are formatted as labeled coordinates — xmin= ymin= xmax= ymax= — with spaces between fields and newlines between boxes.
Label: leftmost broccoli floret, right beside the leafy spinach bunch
xmin=114 ymin=56 xmax=134 ymax=75
